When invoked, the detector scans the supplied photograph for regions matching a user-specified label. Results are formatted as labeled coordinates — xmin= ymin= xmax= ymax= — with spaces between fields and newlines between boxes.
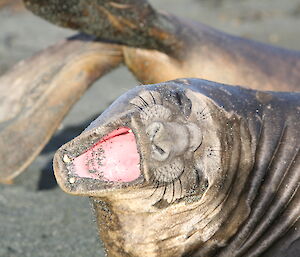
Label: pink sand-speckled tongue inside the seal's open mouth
xmin=73 ymin=127 xmax=141 ymax=182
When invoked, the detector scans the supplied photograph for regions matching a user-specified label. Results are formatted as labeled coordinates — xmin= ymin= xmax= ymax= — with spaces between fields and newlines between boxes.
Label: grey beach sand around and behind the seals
xmin=0 ymin=0 xmax=300 ymax=257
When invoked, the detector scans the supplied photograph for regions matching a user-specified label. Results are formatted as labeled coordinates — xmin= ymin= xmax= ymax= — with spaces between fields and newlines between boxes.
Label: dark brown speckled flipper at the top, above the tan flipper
xmin=24 ymin=0 xmax=192 ymax=56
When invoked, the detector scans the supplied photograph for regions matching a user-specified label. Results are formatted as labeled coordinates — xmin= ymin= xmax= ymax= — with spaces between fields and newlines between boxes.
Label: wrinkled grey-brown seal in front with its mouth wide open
xmin=54 ymin=79 xmax=300 ymax=257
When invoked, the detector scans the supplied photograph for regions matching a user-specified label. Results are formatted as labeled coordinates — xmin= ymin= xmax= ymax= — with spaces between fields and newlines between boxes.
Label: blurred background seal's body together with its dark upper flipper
xmin=24 ymin=0 xmax=300 ymax=91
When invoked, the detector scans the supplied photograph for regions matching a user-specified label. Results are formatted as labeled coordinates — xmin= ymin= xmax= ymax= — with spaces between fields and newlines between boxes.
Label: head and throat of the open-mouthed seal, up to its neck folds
xmin=54 ymin=81 xmax=251 ymax=256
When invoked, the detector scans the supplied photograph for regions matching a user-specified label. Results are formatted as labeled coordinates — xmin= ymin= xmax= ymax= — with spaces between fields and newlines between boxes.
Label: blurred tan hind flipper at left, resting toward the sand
xmin=0 ymin=35 xmax=123 ymax=183
